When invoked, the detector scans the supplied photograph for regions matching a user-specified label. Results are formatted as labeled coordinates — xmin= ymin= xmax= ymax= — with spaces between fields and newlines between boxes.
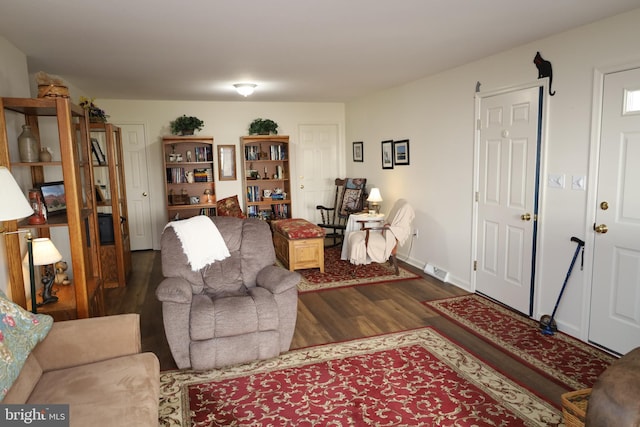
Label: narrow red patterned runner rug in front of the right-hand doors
xmin=425 ymin=294 xmax=615 ymax=390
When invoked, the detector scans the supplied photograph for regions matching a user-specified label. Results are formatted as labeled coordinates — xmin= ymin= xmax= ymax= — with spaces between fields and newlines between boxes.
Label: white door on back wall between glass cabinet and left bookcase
xmin=119 ymin=124 xmax=153 ymax=251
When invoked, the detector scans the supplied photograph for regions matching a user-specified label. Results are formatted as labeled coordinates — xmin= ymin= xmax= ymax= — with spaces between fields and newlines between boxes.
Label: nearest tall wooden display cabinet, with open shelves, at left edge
xmin=0 ymin=97 xmax=104 ymax=320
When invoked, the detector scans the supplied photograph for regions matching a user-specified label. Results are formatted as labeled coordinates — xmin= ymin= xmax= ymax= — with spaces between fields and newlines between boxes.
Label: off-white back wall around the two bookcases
xmin=95 ymin=99 xmax=344 ymax=249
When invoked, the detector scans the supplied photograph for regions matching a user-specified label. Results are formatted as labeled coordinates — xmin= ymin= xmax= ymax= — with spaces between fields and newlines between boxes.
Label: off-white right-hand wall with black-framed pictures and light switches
xmin=346 ymin=9 xmax=640 ymax=338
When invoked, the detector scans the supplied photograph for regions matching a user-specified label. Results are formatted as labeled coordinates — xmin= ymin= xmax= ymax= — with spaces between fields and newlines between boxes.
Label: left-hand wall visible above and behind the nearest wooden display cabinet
xmin=0 ymin=37 xmax=30 ymax=297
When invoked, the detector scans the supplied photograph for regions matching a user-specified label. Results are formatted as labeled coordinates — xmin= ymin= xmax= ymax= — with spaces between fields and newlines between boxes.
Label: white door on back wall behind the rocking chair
xmin=292 ymin=124 xmax=340 ymax=224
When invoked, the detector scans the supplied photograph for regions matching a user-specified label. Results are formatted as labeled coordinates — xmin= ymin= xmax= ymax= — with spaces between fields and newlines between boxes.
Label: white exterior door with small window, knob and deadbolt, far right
xmin=589 ymin=69 xmax=640 ymax=354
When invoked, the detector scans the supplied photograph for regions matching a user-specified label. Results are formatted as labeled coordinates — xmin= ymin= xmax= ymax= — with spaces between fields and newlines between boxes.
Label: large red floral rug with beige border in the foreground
xmin=160 ymin=328 xmax=562 ymax=426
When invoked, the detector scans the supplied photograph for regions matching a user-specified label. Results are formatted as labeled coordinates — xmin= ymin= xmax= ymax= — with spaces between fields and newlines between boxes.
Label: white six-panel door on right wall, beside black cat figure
xmin=475 ymin=87 xmax=540 ymax=315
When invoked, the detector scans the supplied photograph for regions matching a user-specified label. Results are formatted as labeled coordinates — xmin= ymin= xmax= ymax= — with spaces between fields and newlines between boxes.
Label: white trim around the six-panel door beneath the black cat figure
xmin=469 ymin=78 xmax=549 ymax=314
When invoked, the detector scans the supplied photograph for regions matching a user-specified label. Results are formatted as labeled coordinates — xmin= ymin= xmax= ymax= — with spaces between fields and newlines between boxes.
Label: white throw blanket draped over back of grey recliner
xmin=164 ymin=215 xmax=231 ymax=271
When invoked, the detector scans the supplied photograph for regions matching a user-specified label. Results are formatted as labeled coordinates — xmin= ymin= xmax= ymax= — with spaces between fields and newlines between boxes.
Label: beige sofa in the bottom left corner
xmin=2 ymin=314 xmax=160 ymax=427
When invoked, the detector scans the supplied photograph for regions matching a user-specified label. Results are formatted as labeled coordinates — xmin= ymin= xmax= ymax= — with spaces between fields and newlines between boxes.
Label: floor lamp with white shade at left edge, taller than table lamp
xmin=0 ymin=166 xmax=44 ymax=313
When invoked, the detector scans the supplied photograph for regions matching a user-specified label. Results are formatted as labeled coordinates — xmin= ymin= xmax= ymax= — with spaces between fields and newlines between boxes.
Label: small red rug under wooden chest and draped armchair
xmin=290 ymin=246 xmax=419 ymax=293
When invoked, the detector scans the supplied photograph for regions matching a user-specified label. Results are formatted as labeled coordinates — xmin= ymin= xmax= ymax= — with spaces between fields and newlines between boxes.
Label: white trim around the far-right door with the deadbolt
xmin=577 ymin=60 xmax=640 ymax=342
